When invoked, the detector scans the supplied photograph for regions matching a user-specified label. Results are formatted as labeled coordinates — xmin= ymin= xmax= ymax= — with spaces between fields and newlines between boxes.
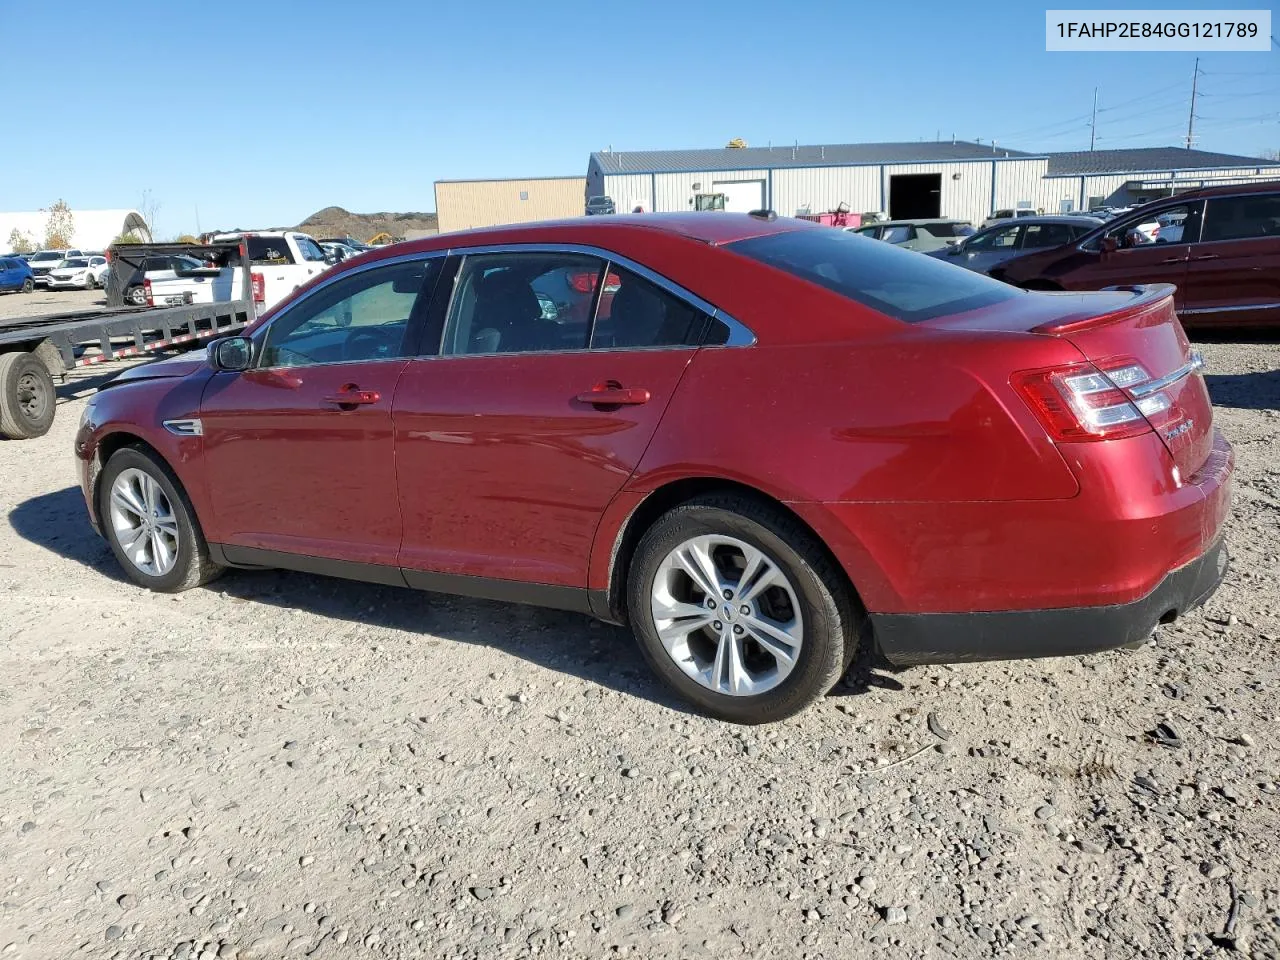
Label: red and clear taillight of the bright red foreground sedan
xmin=1014 ymin=360 xmax=1170 ymax=442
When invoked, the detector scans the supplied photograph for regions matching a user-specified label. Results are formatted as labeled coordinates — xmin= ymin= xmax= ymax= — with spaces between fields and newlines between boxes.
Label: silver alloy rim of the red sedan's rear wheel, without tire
xmin=650 ymin=534 xmax=804 ymax=696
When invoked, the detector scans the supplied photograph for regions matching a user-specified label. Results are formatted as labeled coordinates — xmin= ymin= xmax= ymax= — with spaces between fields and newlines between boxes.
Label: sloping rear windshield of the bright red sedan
xmin=726 ymin=229 xmax=1019 ymax=324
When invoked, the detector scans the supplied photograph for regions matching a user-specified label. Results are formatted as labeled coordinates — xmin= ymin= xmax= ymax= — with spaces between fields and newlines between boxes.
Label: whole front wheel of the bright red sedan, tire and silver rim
xmin=97 ymin=447 xmax=223 ymax=593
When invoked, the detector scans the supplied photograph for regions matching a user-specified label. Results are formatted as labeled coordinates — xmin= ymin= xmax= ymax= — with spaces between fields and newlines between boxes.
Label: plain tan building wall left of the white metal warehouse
xmin=435 ymin=177 xmax=586 ymax=233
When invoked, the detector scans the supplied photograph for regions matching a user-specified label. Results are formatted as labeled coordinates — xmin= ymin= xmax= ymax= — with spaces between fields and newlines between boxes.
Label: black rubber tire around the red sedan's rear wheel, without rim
xmin=627 ymin=494 xmax=865 ymax=723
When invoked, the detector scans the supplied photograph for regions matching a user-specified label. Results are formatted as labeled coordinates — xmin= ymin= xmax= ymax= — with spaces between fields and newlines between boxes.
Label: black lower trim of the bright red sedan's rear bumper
xmin=870 ymin=538 xmax=1228 ymax=666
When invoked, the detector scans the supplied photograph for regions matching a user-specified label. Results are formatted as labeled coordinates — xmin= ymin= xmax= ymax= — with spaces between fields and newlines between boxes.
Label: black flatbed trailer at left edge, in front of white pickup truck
xmin=0 ymin=248 xmax=257 ymax=440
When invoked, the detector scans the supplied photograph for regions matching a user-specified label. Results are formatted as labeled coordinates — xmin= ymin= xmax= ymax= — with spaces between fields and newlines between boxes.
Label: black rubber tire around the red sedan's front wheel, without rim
xmin=97 ymin=447 xmax=225 ymax=594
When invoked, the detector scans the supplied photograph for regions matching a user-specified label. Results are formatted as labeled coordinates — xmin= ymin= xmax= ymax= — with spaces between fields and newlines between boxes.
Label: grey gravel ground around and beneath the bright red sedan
xmin=0 ymin=343 xmax=1280 ymax=960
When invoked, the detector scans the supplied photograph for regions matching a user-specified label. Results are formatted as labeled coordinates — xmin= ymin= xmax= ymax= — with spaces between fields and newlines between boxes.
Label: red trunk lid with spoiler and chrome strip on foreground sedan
xmin=929 ymin=284 xmax=1213 ymax=480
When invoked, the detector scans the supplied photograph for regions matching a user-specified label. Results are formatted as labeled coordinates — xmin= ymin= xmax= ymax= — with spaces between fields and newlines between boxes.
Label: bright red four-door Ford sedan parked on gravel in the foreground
xmin=76 ymin=214 xmax=1233 ymax=722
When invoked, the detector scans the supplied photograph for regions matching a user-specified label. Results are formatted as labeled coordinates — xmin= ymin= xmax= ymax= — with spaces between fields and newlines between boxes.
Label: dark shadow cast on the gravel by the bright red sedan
xmin=9 ymin=486 xmax=904 ymax=713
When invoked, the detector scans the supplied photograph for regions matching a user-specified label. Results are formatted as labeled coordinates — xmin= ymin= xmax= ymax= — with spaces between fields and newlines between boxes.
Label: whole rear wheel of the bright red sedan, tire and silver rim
xmin=627 ymin=495 xmax=861 ymax=723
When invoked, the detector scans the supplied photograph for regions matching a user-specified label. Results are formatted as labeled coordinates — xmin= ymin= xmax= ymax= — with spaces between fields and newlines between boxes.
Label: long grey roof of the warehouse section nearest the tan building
xmin=591 ymin=140 xmax=1044 ymax=174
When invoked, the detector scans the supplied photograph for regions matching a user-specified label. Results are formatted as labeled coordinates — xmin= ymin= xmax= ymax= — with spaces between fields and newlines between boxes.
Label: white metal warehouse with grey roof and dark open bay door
xmin=586 ymin=141 xmax=1280 ymax=223
